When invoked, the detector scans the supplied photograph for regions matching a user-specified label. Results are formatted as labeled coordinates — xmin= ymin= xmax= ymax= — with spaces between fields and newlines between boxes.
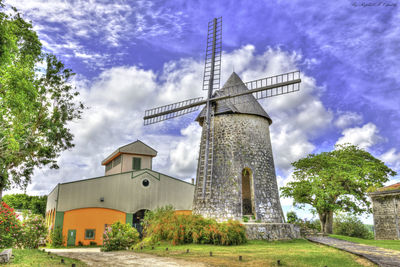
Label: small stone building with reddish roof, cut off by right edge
xmin=368 ymin=183 xmax=400 ymax=240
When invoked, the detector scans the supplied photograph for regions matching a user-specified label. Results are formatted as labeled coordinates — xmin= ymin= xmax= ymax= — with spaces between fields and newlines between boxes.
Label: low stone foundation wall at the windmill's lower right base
xmin=243 ymin=223 xmax=301 ymax=241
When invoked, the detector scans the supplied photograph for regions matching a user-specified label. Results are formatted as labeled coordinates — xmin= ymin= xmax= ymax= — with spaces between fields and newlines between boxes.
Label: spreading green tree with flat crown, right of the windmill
xmin=281 ymin=144 xmax=396 ymax=233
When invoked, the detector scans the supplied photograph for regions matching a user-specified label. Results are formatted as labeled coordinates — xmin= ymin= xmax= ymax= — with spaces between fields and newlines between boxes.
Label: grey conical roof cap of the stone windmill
xmin=196 ymin=72 xmax=272 ymax=124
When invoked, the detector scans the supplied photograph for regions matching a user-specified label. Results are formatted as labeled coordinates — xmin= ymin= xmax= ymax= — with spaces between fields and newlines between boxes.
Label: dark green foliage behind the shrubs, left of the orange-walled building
xmin=3 ymin=194 xmax=47 ymax=216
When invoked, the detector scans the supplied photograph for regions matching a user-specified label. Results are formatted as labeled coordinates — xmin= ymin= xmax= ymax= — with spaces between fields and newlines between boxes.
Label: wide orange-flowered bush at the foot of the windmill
xmin=143 ymin=207 xmax=246 ymax=245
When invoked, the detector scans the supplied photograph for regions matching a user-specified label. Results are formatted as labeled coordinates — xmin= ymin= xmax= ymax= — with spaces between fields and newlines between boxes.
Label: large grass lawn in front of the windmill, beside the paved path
xmin=131 ymin=239 xmax=375 ymax=267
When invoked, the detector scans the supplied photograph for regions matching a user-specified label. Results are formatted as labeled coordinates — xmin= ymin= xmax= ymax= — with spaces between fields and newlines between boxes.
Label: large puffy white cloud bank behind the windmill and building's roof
xmin=4 ymin=45 xmax=332 ymax=197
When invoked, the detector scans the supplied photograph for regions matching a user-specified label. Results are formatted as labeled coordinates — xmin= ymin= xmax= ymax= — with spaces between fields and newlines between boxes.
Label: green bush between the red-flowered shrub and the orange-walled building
xmin=18 ymin=214 xmax=47 ymax=248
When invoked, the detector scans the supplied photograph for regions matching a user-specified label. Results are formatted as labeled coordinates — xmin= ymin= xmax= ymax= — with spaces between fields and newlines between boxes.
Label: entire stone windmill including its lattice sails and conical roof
xmin=144 ymin=18 xmax=301 ymax=223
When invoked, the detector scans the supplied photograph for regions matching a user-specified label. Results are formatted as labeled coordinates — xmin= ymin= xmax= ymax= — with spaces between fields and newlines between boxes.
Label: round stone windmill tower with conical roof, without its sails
xmin=193 ymin=73 xmax=284 ymax=223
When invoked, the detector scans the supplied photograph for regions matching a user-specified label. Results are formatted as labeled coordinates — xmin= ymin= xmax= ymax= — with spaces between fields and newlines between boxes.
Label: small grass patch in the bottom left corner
xmin=7 ymin=248 xmax=87 ymax=267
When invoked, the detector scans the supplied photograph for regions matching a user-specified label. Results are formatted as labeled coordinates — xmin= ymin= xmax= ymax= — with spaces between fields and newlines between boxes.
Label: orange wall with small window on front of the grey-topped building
xmin=63 ymin=208 xmax=126 ymax=245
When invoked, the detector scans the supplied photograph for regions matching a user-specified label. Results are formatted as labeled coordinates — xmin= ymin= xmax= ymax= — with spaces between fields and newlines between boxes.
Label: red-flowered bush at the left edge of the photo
xmin=0 ymin=202 xmax=21 ymax=248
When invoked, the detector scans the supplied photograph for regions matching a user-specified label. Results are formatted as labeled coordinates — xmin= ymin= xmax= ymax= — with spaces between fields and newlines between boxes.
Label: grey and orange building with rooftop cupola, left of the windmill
xmin=46 ymin=140 xmax=194 ymax=245
